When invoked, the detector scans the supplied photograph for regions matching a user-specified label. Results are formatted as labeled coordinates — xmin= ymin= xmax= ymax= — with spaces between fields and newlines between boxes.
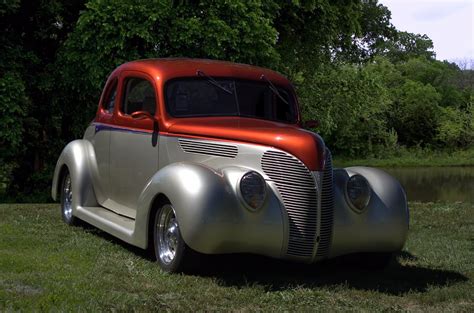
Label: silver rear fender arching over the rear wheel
xmin=51 ymin=139 xmax=98 ymax=207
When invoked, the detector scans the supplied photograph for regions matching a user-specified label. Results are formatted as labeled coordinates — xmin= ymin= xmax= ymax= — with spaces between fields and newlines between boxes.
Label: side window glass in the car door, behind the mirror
xmin=122 ymin=77 xmax=156 ymax=115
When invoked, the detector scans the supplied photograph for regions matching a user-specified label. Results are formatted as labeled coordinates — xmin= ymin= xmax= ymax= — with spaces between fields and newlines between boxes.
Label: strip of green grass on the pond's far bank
xmin=334 ymin=148 xmax=474 ymax=167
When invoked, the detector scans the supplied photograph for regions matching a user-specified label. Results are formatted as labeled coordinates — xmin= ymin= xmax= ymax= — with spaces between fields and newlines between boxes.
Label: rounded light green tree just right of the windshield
xmin=300 ymin=65 xmax=390 ymax=157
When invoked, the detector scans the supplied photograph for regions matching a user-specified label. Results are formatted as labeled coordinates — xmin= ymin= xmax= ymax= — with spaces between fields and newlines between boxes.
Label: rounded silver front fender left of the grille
xmin=136 ymin=162 xmax=284 ymax=257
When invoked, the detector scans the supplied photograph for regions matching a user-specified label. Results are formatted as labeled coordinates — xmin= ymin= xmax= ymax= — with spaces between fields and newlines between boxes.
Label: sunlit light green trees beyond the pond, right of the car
xmin=299 ymin=56 xmax=474 ymax=157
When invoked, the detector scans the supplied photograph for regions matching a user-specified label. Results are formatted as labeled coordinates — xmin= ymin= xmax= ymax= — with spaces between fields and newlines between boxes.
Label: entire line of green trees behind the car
xmin=0 ymin=0 xmax=474 ymax=201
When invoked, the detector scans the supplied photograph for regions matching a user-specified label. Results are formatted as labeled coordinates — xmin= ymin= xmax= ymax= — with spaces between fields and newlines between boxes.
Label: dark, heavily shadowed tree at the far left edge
xmin=0 ymin=0 xmax=82 ymax=199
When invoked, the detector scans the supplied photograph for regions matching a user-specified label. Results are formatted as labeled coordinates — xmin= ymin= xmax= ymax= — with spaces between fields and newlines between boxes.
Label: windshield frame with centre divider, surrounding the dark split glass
xmin=163 ymin=75 xmax=299 ymax=125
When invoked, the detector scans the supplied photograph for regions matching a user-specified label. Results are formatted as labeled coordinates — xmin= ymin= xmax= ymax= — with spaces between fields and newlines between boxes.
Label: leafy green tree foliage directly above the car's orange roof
xmin=55 ymin=0 xmax=278 ymax=137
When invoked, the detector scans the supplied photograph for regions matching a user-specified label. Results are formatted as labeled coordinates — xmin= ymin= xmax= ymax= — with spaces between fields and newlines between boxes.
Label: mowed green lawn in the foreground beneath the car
xmin=0 ymin=203 xmax=474 ymax=312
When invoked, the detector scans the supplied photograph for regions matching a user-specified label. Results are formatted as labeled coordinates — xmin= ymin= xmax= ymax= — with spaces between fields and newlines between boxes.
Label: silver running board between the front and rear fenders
xmin=74 ymin=206 xmax=136 ymax=245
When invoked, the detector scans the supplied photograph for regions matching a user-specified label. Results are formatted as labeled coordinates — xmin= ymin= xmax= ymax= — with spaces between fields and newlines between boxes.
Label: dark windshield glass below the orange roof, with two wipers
xmin=165 ymin=78 xmax=297 ymax=124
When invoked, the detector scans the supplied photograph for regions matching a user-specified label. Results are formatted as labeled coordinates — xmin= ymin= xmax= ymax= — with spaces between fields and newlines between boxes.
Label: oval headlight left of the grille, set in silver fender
xmin=240 ymin=171 xmax=267 ymax=211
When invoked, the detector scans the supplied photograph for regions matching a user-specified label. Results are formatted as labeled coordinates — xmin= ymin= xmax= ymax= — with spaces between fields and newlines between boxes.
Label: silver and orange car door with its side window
xmin=106 ymin=71 xmax=159 ymax=218
